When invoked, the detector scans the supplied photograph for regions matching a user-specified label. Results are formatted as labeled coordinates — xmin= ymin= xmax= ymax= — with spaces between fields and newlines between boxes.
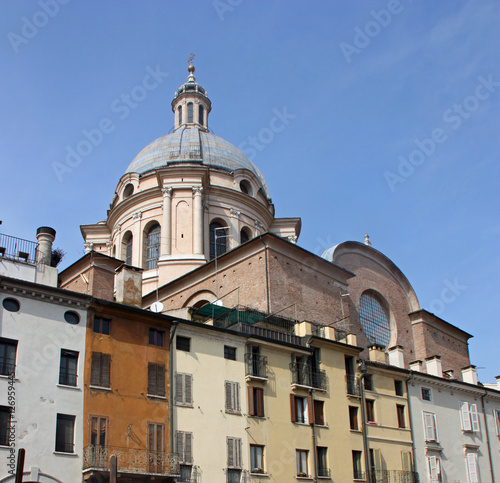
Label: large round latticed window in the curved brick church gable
xmin=359 ymin=294 xmax=391 ymax=347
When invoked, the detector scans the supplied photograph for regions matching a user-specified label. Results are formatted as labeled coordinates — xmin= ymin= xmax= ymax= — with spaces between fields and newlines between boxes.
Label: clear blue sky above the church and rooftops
xmin=0 ymin=0 xmax=500 ymax=382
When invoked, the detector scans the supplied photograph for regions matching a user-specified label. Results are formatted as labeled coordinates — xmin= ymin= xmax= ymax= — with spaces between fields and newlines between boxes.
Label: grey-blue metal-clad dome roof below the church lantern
xmin=126 ymin=125 xmax=269 ymax=198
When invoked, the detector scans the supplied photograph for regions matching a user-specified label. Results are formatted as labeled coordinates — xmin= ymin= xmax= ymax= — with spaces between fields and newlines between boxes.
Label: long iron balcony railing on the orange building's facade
xmin=83 ymin=446 xmax=179 ymax=475
